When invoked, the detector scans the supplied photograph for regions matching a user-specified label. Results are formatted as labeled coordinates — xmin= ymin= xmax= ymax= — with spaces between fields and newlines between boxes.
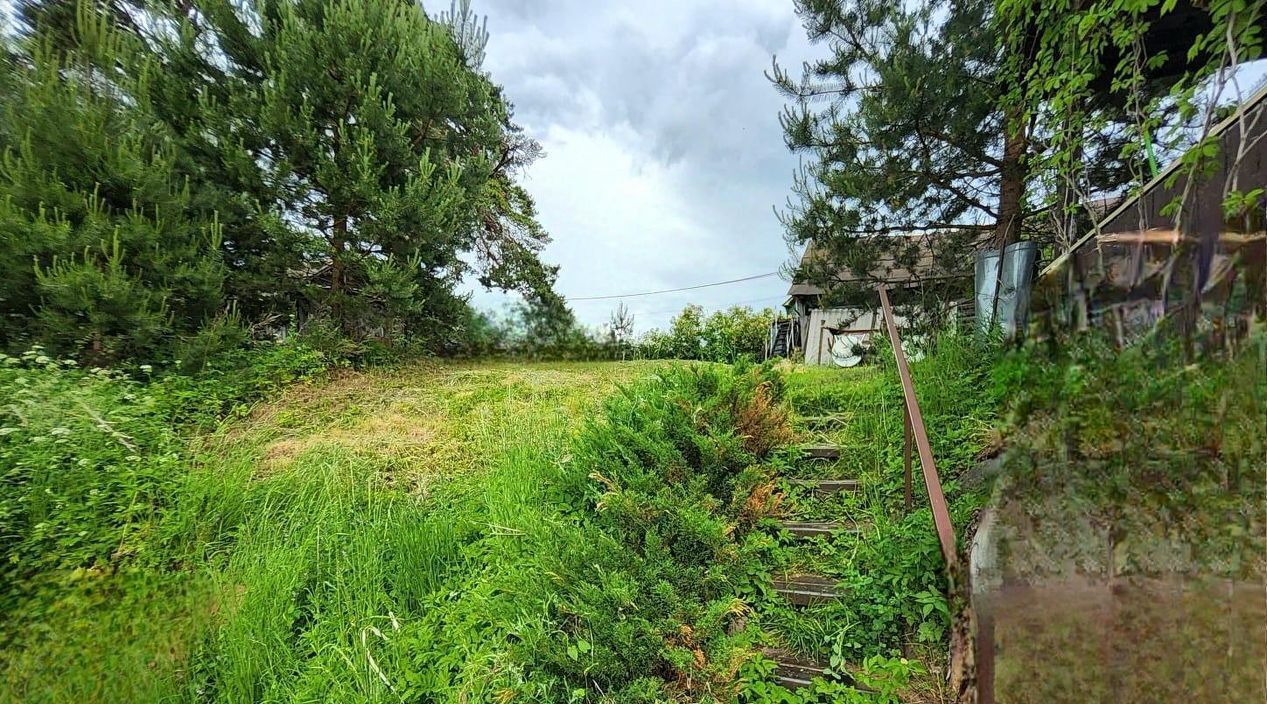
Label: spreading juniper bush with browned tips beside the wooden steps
xmin=535 ymin=367 xmax=791 ymax=701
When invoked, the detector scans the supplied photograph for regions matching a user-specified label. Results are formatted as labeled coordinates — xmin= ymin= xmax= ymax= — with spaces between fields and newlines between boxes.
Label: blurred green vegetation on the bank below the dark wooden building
xmin=995 ymin=329 xmax=1267 ymax=577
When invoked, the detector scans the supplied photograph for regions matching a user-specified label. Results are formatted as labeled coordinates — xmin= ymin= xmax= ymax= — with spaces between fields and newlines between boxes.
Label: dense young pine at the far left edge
xmin=0 ymin=13 xmax=224 ymax=363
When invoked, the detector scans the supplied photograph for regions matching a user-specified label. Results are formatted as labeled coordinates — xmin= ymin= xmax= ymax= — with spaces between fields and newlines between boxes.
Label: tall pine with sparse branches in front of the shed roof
xmin=770 ymin=0 xmax=1025 ymax=310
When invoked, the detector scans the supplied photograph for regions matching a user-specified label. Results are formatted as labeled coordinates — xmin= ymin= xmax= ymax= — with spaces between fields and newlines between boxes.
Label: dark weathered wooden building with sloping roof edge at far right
xmin=1034 ymin=82 xmax=1267 ymax=339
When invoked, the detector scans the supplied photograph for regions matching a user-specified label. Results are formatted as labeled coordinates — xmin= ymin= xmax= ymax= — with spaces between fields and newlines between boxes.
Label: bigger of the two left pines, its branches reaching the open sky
xmin=9 ymin=0 xmax=563 ymax=352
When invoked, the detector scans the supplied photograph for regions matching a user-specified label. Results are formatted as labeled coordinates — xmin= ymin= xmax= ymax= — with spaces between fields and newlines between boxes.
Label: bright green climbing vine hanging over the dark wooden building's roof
xmin=996 ymin=0 xmax=1267 ymax=247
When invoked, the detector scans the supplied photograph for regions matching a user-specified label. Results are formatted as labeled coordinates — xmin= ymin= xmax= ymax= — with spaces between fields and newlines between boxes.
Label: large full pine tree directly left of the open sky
xmin=157 ymin=0 xmax=555 ymax=341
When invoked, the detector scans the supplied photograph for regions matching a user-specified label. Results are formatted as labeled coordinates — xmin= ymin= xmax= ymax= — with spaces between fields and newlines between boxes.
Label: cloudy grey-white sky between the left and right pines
xmin=440 ymin=0 xmax=811 ymax=333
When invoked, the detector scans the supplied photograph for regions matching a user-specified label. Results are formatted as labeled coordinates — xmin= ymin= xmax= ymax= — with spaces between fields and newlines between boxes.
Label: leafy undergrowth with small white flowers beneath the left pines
xmin=0 ymin=344 xmax=328 ymax=614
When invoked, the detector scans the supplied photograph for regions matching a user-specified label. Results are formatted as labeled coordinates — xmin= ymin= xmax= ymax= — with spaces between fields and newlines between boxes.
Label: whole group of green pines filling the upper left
xmin=0 ymin=0 xmax=570 ymax=365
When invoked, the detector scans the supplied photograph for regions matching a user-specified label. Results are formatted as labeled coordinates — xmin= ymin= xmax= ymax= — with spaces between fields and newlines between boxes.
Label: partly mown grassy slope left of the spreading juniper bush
xmin=0 ymin=362 xmax=656 ymax=703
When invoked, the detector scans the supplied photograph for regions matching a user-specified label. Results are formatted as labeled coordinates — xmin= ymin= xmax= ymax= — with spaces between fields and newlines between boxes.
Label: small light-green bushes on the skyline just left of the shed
xmin=636 ymin=305 xmax=774 ymax=363
